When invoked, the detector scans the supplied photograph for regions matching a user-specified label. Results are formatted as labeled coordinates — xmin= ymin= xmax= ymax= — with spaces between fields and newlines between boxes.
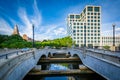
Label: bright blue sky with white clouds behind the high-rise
xmin=0 ymin=0 xmax=120 ymax=40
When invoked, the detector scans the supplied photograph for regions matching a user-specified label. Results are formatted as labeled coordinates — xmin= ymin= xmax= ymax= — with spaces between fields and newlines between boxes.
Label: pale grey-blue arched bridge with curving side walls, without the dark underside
xmin=0 ymin=49 xmax=120 ymax=80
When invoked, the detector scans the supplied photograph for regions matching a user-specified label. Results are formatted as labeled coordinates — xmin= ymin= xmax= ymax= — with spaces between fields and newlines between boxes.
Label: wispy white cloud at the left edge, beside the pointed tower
xmin=0 ymin=19 xmax=13 ymax=35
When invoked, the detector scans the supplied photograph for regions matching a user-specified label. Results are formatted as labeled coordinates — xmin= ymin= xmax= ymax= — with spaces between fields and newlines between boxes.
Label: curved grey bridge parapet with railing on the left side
xmin=0 ymin=50 xmax=35 ymax=80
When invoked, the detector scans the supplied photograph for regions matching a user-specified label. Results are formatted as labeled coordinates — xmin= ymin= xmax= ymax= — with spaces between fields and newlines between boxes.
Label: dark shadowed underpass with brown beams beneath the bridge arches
xmin=24 ymin=53 xmax=104 ymax=80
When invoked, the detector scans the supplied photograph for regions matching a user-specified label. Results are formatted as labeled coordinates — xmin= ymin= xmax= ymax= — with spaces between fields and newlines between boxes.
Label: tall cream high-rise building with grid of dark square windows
xmin=67 ymin=5 xmax=101 ymax=47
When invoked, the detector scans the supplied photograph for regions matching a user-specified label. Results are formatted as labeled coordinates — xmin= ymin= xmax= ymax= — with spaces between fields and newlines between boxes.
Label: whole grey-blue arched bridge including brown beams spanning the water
xmin=0 ymin=49 xmax=120 ymax=80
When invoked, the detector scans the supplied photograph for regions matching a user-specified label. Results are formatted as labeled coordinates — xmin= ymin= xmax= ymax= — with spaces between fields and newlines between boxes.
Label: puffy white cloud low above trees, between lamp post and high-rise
xmin=35 ymin=24 xmax=66 ymax=40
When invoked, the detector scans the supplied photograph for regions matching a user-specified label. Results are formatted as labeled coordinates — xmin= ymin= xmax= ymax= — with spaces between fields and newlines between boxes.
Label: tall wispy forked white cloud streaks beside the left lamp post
xmin=18 ymin=0 xmax=42 ymax=38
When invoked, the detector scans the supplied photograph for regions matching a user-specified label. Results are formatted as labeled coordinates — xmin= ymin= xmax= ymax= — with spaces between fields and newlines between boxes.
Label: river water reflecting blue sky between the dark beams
xmin=45 ymin=64 xmax=68 ymax=80
